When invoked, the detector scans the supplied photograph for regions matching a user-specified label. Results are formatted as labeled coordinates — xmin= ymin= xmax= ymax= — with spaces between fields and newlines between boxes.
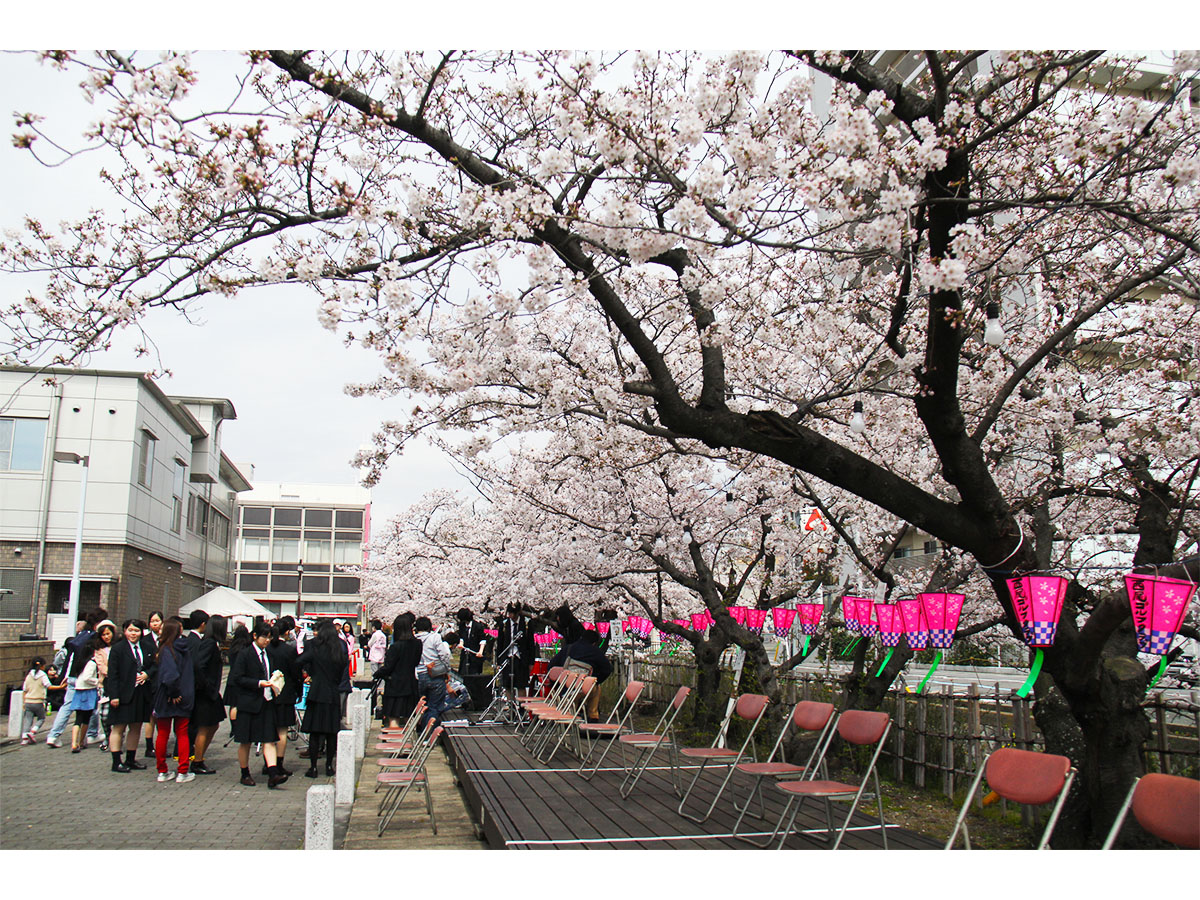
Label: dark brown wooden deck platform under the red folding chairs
xmin=445 ymin=722 xmax=942 ymax=850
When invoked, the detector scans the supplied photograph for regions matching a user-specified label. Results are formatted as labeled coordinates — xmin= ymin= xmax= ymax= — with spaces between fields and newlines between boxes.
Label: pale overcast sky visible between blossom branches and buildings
xmin=0 ymin=54 xmax=470 ymax=524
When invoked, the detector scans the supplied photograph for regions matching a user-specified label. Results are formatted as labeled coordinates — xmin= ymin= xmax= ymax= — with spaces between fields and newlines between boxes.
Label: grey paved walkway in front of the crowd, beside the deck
xmin=0 ymin=716 xmax=486 ymax=850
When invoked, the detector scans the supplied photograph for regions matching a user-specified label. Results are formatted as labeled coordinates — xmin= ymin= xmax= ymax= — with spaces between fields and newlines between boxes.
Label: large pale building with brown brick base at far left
xmin=0 ymin=366 xmax=250 ymax=640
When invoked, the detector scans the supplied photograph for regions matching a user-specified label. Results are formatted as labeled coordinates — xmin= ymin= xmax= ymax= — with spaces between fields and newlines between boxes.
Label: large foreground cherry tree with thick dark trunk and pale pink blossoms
xmin=0 ymin=50 xmax=1200 ymax=846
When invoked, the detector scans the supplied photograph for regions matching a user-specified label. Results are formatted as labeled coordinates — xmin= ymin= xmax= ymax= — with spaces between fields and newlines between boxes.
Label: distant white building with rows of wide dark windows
xmin=236 ymin=482 xmax=371 ymax=618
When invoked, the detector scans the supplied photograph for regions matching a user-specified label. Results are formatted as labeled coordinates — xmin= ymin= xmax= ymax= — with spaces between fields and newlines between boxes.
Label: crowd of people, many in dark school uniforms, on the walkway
xmin=22 ymin=605 xmax=611 ymax=788
